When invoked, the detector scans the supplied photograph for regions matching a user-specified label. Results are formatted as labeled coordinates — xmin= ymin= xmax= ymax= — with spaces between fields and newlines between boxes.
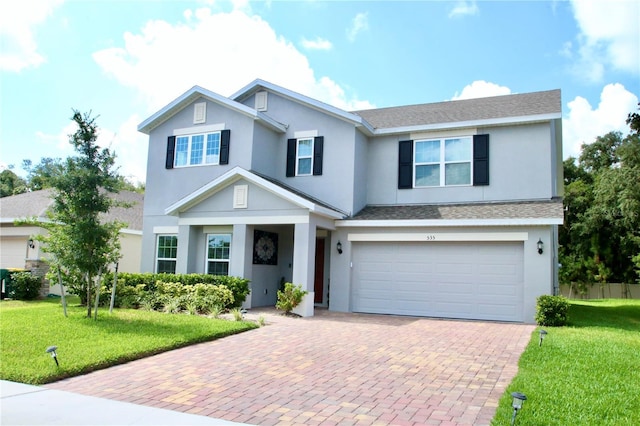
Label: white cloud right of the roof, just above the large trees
xmin=562 ymin=83 xmax=638 ymax=158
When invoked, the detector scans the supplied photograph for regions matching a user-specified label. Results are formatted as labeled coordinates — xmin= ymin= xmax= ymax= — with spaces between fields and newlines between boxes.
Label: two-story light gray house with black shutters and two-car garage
xmin=138 ymin=80 xmax=563 ymax=322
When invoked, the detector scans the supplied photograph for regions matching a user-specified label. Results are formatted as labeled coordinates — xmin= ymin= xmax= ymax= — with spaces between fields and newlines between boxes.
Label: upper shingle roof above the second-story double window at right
xmin=354 ymin=89 xmax=562 ymax=129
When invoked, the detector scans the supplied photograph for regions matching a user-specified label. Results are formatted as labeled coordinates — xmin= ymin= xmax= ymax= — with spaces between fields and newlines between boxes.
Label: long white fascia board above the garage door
xmin=336 ymin=217 xmax=564 ymax=228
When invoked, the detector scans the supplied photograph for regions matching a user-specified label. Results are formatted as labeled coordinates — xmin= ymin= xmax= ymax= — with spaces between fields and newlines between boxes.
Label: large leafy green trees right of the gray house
xmin=559 ymin=123 xmax=640 ymax=283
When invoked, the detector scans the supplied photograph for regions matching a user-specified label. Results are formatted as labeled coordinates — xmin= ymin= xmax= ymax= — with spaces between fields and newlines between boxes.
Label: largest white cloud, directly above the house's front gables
xmin=93 ymin=9 xmax=372 ymax=112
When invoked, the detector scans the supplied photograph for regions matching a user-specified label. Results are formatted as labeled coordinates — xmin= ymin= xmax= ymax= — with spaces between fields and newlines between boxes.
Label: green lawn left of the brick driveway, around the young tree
xmin=0 ymin=298 xmax=257 ymax=384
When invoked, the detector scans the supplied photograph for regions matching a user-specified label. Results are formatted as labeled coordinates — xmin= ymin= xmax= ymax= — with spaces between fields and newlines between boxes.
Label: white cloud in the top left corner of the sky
xmin=0 ymin=0 xmax=62 ymax=72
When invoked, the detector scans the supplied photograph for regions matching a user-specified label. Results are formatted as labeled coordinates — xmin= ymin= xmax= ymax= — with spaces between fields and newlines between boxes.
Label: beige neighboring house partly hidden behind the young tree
xmin=0 ymin=189 xmax=144 ymax=294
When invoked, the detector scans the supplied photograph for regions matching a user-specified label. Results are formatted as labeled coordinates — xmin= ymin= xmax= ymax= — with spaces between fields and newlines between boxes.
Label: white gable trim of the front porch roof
xmin=164 ymin=166 xmax=346 ymax=219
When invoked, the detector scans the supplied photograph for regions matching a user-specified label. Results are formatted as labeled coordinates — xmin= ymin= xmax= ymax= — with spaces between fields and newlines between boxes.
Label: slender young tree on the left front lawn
xmin=30 ymin=111 xmax=124 ymax=317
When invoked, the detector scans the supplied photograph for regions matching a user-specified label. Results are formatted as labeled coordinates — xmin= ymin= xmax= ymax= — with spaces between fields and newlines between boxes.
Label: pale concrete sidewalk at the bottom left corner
xmin=0 ymin=380 xmax=248 ymax=426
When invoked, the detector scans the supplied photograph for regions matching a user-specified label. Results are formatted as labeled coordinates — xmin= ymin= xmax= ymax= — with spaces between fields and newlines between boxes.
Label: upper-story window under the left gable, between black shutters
xmin=173 ymin=132 xmax=220 ymax=167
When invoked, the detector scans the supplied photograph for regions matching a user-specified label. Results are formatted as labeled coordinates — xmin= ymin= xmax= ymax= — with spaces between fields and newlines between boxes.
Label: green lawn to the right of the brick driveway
xmin=492 ymin=299 xmax=640 ymax=426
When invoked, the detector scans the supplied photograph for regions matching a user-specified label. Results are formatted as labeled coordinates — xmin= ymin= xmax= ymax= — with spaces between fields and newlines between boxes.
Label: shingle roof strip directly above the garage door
xmin=350 ymin=198 xmax=564 ymax=220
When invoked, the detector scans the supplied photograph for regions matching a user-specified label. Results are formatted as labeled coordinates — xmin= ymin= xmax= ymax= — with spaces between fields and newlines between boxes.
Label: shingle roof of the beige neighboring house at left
xmin=0 ymin=189 xmax=144 ymax=231
